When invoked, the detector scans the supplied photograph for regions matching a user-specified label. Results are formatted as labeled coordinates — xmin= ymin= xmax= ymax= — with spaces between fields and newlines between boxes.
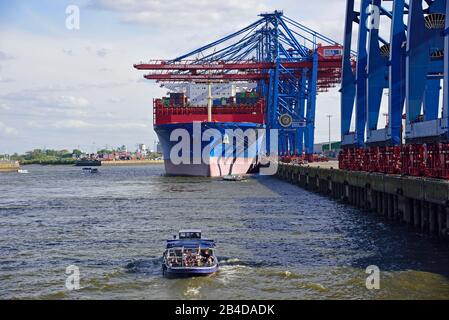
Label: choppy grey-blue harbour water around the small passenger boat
xmin=0 ymin=166 xmax=449 ymax=299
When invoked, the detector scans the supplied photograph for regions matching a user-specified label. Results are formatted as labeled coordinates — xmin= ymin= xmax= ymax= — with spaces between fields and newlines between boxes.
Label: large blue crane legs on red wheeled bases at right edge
xmin=339 ymin=0 xmax=449 ymax=179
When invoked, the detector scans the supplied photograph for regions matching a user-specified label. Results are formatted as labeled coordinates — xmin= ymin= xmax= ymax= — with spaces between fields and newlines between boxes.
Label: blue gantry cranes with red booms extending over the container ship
xmin=134 ymin=11 xmax=344 ymax=158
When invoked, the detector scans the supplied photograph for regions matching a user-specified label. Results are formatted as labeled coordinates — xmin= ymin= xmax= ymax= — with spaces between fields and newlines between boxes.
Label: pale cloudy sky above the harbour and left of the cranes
xmin=0 ymin=0 xmax=346 ymax=154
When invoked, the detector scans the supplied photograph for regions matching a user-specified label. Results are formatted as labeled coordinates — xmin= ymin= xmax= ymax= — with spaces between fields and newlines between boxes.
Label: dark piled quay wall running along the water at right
xmin=277 ymin=164 xmax=449 ymax=239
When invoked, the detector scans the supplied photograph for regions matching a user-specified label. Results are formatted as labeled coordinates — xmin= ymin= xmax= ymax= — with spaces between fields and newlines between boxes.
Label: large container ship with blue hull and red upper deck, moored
xmin=153 ymin=83 xmax=265 ymax=177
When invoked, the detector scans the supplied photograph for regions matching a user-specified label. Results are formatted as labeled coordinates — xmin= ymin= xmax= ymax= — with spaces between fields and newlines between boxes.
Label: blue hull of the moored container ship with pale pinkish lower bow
xmin=154 ymin=122 xmax=265 ymax=177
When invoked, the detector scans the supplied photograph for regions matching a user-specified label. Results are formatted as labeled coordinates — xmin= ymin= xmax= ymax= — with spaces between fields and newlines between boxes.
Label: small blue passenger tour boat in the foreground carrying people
xmin=162 ymin=230 xmax=218 ymax=277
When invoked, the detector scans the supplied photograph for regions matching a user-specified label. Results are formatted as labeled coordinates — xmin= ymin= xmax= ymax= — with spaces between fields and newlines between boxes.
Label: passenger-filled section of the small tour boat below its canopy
xmin=165 ymin=248 xmax=217 ymax=268
